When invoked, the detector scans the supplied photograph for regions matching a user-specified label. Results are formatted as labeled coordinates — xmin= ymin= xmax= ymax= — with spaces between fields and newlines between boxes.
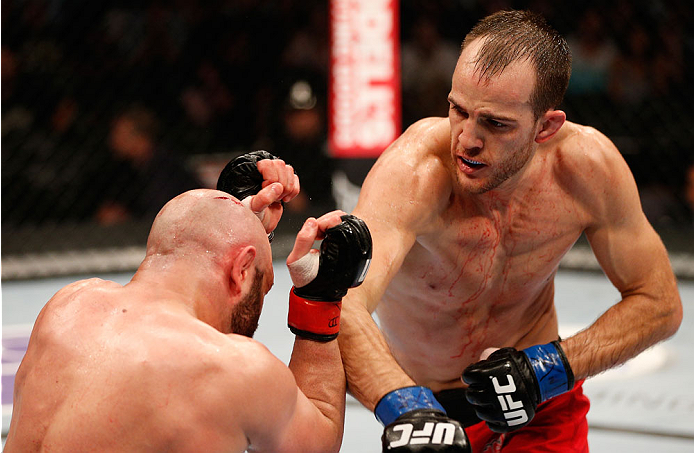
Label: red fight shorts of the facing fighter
xmin=436 ymin=381 xmax=590 ymax=453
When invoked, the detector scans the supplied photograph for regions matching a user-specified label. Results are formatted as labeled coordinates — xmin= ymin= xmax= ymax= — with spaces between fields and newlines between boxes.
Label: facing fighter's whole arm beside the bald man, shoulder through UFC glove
xmin=340 ymin=120 xmax=470 ymax=453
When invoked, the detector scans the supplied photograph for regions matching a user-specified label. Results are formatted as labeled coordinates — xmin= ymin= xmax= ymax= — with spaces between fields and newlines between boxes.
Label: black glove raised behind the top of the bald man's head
xmin=217 ymin=150 xmax=278 ymax=200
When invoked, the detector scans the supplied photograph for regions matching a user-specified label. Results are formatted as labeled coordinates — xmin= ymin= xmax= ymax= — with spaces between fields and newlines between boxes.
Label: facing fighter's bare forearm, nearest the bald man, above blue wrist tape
xmin=338 ymin=297 xmax=415 ymax=411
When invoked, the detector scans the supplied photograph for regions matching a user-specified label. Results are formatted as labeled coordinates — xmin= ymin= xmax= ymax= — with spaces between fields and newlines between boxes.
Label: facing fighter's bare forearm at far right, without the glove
xmin=561 ymin=287 xmax=682 ymax=380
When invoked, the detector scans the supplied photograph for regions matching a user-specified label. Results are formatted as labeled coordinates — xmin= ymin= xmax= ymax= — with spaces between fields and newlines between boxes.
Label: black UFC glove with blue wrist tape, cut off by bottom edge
xmin=374 ymin=386 xmax=472 ymax=453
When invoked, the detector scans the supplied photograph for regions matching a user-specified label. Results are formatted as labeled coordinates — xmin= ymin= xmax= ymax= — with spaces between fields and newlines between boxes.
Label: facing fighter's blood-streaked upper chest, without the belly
xmin=410 ymin=189 xmax=582 ymax=298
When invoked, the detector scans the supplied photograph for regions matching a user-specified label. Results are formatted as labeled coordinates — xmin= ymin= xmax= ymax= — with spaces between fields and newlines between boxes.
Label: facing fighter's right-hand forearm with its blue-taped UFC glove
xmin=463 ymin=285 xmax=681 ymax=432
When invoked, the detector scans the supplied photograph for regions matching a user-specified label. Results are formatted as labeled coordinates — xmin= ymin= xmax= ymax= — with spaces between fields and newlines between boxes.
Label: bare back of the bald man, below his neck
xmin=8 ymin=279 xmax=278 ymax=451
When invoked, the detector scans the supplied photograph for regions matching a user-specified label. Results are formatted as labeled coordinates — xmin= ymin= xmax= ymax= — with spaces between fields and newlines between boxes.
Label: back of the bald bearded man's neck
xmin=128 ymin=256 xmax=232 ymax=330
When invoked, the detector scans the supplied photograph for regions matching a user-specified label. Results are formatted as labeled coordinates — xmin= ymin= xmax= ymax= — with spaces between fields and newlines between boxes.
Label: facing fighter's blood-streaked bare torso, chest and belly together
xmin=378 ymin=188 xmax=583 ymax=383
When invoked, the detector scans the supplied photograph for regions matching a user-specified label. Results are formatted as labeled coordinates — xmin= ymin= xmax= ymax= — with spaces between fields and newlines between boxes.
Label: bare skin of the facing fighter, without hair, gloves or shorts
xmin=340 ymin=38 xmax=682 ymax=409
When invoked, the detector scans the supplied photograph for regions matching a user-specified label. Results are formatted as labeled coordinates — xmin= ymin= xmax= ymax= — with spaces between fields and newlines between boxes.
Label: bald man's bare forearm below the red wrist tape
xmin=289 ymin=337 xmax=346 ymax=444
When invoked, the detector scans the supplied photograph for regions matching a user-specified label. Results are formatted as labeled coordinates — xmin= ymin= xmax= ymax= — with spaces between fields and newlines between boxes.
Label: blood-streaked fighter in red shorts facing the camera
xmin=339 ymin=11 xmax=682 ymax=452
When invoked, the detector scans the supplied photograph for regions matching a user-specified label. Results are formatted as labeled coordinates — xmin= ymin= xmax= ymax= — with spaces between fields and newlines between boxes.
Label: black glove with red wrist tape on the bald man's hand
xmin=287 ymin=215 xmax=372 ymax=341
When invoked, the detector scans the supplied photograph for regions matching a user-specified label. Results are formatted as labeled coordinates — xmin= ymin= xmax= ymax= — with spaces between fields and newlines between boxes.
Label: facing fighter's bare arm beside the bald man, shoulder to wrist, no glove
xmin=339 ymin=122 xmax=450 ymax=410
